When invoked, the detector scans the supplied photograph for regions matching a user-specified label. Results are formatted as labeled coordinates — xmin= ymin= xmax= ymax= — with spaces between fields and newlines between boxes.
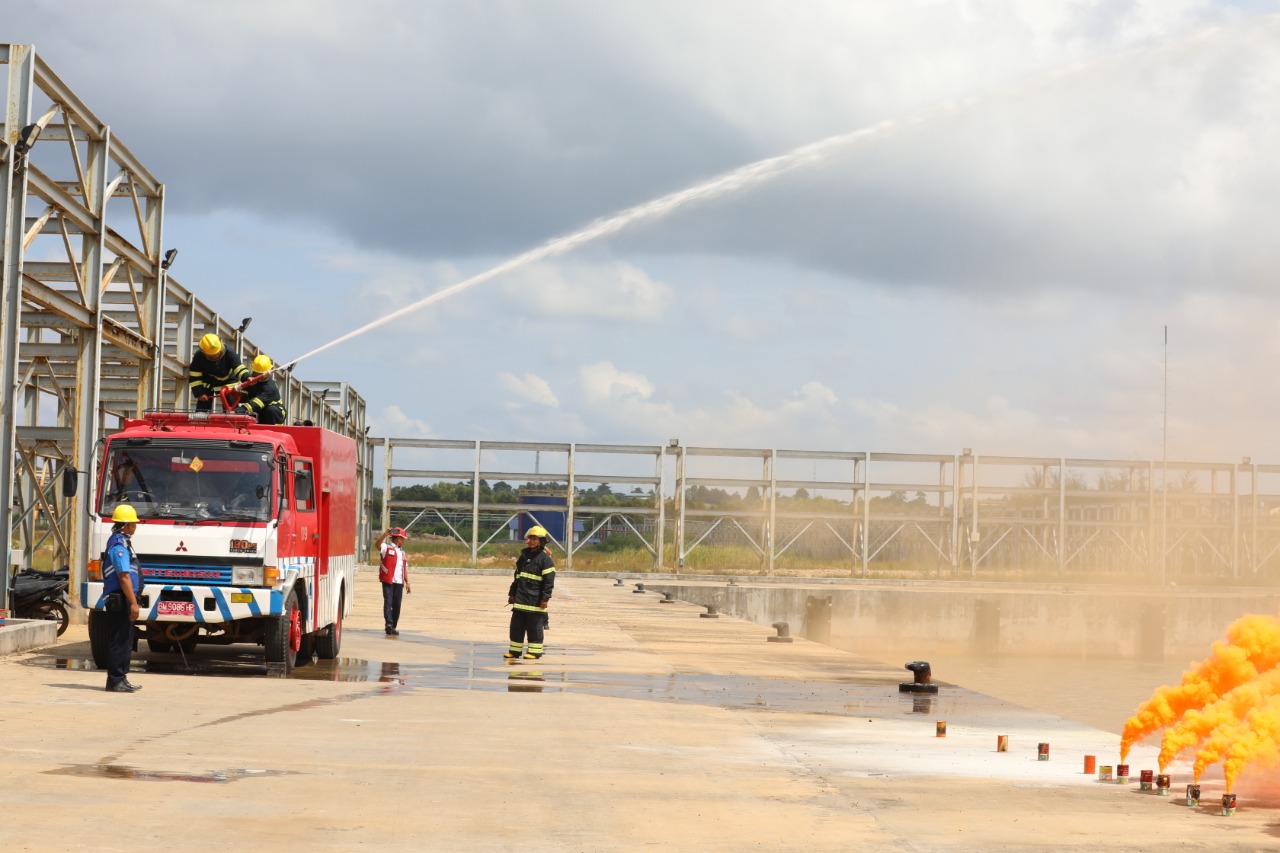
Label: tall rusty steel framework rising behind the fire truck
xmin=0 ymin=44 xmax=371 ymax=602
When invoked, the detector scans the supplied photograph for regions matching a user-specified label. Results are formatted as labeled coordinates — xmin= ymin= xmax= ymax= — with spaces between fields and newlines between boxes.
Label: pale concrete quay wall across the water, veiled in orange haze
xmin=645 ymin=579 xmax=1280 ymax=661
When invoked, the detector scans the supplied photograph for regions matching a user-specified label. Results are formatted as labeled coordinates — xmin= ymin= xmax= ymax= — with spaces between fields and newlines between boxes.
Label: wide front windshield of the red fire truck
xmin=99 ymin=442 xmax=274 ymax=521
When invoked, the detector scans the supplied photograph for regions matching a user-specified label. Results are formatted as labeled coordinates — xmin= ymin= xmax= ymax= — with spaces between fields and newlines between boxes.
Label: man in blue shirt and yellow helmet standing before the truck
xmin=99 ymin=503 xmax=142 ymax=693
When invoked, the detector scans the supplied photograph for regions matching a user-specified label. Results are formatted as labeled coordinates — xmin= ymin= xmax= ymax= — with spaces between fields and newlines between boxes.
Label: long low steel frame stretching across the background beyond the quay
xmin=379 ymin=438 xmax=1280 ymax=583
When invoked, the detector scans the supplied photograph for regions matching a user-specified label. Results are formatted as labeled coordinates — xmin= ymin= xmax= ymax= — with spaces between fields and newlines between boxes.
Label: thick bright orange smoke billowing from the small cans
xmin=1120 ymin=616 xmax=1280 ymax=767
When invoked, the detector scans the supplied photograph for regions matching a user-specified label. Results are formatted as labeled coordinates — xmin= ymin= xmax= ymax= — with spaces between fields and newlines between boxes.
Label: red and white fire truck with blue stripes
xmin=81 ymin=412 xmax=357 ymax=672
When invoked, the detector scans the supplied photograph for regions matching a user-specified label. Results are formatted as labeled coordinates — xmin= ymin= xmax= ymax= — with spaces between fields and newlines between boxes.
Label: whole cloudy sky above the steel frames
xmin=10 ymin=0 xmax=1280 ymax=462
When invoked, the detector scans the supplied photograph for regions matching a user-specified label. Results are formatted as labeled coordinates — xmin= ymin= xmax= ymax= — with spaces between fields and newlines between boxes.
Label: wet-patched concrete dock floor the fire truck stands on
xmin=0 ymin=571 xmax=1280 ymax=852
